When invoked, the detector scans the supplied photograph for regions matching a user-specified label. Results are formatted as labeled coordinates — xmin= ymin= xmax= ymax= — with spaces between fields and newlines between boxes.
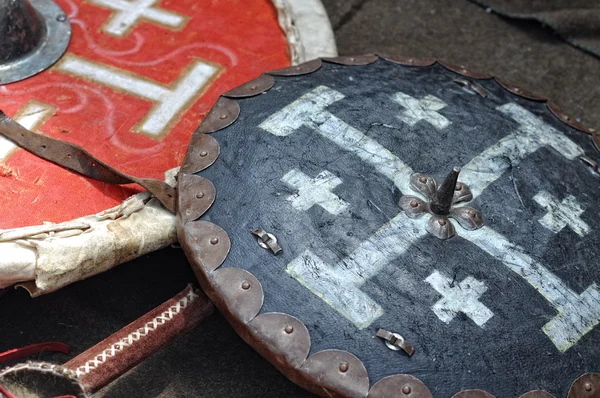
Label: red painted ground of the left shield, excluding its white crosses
xmin=0 ymin=0 xmax=290 ymax=229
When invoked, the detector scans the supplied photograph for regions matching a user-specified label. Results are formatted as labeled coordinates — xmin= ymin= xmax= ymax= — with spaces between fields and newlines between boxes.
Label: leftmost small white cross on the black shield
xmin=281 ymin=169 xmax=348 ymax=215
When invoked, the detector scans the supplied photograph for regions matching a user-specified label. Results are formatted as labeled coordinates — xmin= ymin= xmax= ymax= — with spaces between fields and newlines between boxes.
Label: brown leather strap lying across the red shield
xmin=0 ymin=111 xmax=175 ymax=213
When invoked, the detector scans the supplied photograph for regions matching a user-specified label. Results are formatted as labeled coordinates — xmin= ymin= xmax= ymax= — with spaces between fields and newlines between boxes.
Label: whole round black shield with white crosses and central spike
xmin=179 ymin=56 xmax=600 ymax=397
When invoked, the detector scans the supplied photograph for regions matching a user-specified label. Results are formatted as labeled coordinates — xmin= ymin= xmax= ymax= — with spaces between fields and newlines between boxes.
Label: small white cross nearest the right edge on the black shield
xmin=533 ymin=191 xmax=590 ymax=237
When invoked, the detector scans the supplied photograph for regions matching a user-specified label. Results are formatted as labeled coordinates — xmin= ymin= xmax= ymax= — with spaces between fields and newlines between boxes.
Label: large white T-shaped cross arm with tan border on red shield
xmin=55 ymin=54 xmax=220 ymax=139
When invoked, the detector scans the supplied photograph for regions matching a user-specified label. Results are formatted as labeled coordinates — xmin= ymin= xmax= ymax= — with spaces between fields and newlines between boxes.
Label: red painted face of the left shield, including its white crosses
xmin=0 ymin=0 xmax=290 ymax=229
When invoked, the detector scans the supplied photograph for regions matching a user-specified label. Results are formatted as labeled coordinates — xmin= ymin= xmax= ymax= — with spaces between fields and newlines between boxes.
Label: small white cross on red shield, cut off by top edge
xmin=88 ymin=0 xmax=189 ymax=37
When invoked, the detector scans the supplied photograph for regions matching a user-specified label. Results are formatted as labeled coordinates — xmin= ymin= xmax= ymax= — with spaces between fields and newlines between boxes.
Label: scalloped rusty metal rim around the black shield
xmin=177 ymin=54 xmax=600 ymax=398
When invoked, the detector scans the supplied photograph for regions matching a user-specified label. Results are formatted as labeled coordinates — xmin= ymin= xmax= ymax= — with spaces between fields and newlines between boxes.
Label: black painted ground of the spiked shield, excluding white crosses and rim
xmin=193 ymin=61 xmax=600 ymax=397
